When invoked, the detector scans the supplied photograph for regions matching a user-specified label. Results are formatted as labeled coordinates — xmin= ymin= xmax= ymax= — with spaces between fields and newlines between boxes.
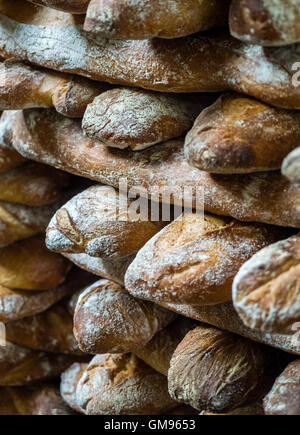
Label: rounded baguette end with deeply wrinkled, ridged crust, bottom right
xmin=168 ymin=326 xmax=280 ymax=412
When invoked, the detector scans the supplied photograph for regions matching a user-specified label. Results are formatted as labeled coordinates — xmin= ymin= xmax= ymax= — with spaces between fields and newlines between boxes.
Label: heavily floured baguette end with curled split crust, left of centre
xmin=46 ymin=184 xmax=166 ymax=259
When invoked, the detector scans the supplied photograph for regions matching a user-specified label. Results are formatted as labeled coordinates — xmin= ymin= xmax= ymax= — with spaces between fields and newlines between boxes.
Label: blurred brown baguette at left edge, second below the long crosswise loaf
xmin=0 ymin=162 xmax=69 ymax=206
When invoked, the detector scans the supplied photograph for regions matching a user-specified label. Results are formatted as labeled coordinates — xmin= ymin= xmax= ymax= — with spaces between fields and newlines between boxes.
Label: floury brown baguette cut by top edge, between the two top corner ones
xmin=84 ymin=0 xmax=229 ymax=39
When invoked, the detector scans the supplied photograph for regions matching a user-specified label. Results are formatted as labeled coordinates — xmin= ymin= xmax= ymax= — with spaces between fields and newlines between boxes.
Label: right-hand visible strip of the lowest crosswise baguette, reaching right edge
xmin=163 ymin=302 xmax=300 ymax=355
